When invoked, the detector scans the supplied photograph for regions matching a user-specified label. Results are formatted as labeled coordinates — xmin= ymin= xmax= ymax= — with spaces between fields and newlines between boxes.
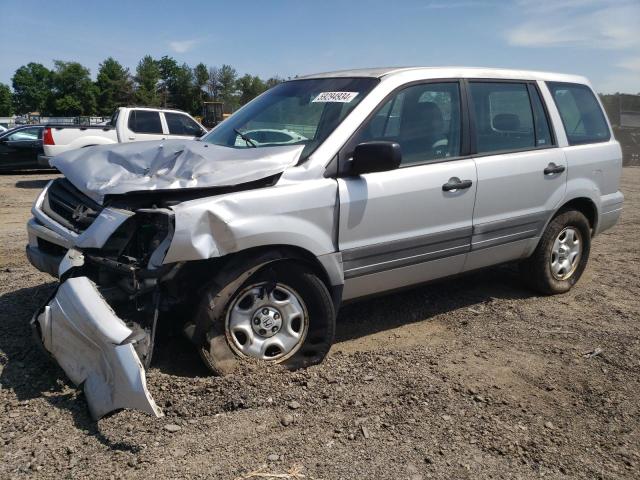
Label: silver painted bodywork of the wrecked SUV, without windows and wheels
xmin=27 ymin=67 xmax=624 ymax=417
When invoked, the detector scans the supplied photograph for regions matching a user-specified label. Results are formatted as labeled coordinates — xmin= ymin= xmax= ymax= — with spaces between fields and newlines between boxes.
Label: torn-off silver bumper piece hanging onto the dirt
xmin=32 ymin=277 xmax=162 ymax=420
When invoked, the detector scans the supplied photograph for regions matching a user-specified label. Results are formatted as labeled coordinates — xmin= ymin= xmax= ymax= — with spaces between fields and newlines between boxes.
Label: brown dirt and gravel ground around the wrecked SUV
xmin=0 ymin=167 xmax=640 ymax=480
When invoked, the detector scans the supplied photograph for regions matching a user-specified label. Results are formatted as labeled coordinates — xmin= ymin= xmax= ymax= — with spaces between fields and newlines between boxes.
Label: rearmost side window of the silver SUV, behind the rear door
xmin=547 ymin=82 xmax=611 ymax=145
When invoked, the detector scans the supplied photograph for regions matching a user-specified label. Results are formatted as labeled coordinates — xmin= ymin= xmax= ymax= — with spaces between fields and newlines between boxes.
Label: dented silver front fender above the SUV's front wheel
xmin=164 ymin=178 xmax=336 ymax=263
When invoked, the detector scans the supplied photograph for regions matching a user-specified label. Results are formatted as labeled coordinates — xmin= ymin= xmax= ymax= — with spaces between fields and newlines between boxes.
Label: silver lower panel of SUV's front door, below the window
xmin=338 ymin=159 xmax=476 ymax=299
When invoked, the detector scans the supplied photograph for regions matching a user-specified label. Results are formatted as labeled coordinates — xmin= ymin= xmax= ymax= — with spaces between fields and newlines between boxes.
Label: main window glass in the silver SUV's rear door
xmin=469 ymin=82 xmax=536 ymax=153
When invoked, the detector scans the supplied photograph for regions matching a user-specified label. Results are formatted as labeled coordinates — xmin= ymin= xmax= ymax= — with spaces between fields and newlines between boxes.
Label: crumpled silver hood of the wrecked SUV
xmin=51 ymin=140 xmax=304 ymax=202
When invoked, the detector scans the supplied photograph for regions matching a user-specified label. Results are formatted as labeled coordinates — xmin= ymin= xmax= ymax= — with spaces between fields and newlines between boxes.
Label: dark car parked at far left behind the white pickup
xmin=0 ymin=125 xmax=44 ymax=171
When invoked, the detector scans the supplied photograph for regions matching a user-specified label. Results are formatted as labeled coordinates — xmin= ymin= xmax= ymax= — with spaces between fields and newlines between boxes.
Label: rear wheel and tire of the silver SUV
xmin=520 ymin=210 xmax=591 ymax=295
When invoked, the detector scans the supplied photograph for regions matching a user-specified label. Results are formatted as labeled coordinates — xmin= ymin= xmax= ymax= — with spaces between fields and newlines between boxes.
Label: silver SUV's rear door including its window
xmin=465 ymin=80 xmax=567 ymax=270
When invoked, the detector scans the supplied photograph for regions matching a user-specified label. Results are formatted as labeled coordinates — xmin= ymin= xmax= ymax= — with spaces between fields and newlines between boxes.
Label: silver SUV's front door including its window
xmin=338 ymin=81 xmax=476 ymax=300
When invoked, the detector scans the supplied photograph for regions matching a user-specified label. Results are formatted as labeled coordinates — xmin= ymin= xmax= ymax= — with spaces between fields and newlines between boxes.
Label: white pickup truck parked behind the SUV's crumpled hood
xmin=38 ymin=107 xmax=207 ymax=167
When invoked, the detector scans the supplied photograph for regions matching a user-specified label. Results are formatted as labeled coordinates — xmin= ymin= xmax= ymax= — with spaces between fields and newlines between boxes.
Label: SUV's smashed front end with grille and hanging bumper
xmin=27 ymin=179 xmax=176 ymax=419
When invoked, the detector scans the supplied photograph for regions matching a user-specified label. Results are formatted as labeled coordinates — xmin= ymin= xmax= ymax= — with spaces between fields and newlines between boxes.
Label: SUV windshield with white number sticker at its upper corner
xmin=201 ymin=78 xmax=378 ymax=158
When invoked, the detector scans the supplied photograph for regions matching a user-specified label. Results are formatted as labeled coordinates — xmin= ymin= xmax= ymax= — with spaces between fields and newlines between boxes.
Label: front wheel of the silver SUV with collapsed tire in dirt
xmin=196 ymin=261 xmax=336 ymax=375
